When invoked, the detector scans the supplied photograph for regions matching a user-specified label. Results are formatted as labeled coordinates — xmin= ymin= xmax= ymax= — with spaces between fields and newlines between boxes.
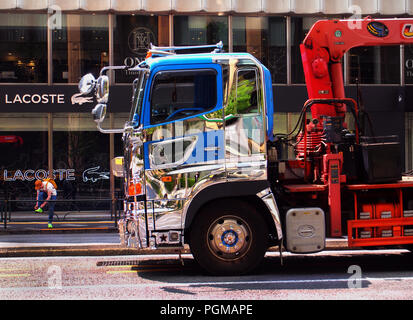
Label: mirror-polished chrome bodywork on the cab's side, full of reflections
xmin=119 ymin=58 xmax=282 ymax=248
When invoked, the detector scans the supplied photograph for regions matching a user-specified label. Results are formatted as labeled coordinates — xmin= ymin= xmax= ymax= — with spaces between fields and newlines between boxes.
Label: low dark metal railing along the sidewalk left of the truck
xmin=0 ymin=199 xmax=123 ymax=229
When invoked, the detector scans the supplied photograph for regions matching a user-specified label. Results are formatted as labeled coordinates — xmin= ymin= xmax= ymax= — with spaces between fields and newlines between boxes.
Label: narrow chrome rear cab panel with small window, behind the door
xmin=225 ymin=60 xmax=266 ymax=180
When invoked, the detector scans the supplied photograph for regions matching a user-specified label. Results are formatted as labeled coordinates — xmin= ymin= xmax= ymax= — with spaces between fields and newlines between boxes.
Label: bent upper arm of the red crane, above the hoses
xmin=300 ymin=18 xmax=413 ymax=119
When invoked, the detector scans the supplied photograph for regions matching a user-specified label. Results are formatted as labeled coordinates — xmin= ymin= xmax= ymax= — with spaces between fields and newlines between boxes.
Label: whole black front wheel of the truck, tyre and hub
xmin=190 ymin=200 xmax=269 ymax=275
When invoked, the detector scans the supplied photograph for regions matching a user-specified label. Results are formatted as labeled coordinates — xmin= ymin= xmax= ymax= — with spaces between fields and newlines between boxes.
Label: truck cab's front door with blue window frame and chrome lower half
xmin=140 ymin=64 xmax=225 ymax=230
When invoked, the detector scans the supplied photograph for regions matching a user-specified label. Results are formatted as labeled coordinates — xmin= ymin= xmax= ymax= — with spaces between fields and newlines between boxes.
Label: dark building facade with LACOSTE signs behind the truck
xmin=0 ymin=0 xmax=413 ymax=202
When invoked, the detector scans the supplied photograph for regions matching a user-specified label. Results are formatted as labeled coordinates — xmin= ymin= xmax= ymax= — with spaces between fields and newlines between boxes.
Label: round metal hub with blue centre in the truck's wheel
xmin=208 ymin=216 xmax=251 ymax=260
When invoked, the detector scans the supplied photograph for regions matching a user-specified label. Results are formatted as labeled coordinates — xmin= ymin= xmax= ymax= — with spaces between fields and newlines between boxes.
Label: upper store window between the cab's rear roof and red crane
xmin=232 ymin=17 xmax=287 ymax=83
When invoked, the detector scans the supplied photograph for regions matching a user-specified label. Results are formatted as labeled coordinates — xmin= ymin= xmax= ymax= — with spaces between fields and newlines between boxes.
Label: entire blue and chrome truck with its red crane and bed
xmin=79 ymin=18 xmax=413 ymax=275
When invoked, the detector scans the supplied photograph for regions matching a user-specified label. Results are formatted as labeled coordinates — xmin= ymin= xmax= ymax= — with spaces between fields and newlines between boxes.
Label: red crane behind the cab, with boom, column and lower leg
xmin=296 ymin=17 xmax=413 ymax=236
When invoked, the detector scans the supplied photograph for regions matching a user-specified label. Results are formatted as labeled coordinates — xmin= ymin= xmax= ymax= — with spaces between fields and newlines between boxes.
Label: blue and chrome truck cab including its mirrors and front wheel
xmin=79 ymin=43 xmax=283 ymax=274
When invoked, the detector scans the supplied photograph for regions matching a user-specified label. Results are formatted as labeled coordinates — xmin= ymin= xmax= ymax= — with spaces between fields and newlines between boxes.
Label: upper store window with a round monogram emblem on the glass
xmin=114 ymin=14 xmax=169 ymax=83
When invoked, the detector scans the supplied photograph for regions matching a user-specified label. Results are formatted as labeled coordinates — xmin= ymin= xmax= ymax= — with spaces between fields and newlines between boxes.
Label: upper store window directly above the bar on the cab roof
xmin=174 ymin=16 xmax=228 ymax=51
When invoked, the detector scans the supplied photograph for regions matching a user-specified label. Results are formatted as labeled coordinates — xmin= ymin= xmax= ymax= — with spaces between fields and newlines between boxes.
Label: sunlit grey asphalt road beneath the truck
xmin=0 ymin=250 xmax=413 ymax=302
